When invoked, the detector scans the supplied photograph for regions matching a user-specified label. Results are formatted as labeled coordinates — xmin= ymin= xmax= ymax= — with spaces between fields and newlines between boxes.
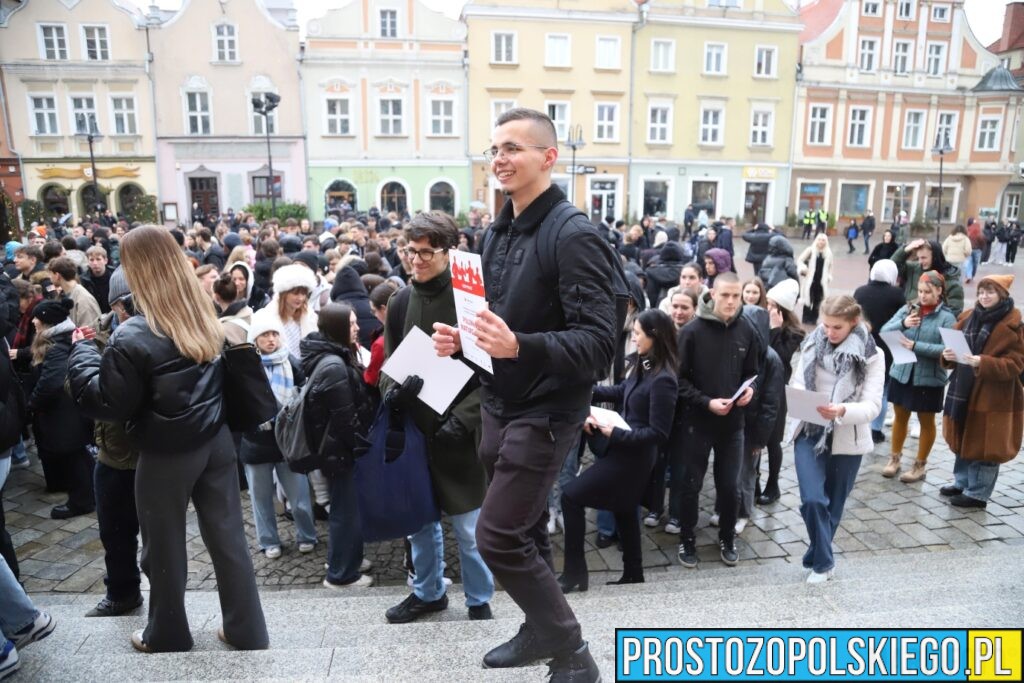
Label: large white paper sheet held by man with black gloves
xmin=381 ymin=327 xmax=473 ymax=415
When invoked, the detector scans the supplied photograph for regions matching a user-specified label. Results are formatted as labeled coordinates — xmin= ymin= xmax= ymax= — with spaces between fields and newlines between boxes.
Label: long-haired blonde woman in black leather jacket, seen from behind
xmin=69 ymin=225 xmax=269 ymax=652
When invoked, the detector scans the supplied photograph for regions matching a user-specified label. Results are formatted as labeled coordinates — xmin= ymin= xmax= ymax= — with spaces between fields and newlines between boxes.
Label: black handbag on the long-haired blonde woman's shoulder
xmin=220 ymin=344 xmax=278 ymax=432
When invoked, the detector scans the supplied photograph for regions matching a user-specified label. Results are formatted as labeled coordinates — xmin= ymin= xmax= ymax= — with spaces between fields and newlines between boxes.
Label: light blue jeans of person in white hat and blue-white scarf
xmin=246 ymin=462 xmax=316 ymax=550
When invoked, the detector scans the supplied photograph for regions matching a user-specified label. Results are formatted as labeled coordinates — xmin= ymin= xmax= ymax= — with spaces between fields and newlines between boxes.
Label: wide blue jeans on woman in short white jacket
xmin=794 ymin=435 xmax=862 ymax=573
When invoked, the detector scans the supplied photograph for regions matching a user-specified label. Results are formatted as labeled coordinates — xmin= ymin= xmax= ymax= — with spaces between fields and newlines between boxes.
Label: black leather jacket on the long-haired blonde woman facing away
xmin=68 ymin=315 xmax=224 ymax=453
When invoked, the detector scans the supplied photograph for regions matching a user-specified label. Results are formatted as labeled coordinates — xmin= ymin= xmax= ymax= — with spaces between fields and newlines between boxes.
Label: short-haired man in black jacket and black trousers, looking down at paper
xmin=673 ymin=272 xmax=762 ymax=568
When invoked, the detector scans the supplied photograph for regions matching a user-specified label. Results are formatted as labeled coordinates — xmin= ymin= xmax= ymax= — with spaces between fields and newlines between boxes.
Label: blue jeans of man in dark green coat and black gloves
xmin=409 ymin=508 xmax=495 ymax=607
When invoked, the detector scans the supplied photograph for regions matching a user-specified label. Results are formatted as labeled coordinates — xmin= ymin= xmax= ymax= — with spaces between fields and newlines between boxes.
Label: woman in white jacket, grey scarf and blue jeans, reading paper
xmin=791 ymin=296 xmax=885 ymax=584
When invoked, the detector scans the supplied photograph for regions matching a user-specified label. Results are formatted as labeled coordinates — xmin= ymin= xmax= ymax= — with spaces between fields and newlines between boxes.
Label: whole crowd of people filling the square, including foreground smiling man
xmin=0 ymin=109 xmax=1024 ymax=681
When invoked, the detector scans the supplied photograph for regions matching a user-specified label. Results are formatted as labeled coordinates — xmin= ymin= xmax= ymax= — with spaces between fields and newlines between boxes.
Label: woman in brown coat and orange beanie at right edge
xmin=940 ymin=274 xmax=1024 ymax=508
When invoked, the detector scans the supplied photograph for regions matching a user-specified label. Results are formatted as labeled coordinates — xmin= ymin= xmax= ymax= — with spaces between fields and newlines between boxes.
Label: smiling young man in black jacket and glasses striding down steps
xmin=434 ymin=109 xmax=616 ymax=683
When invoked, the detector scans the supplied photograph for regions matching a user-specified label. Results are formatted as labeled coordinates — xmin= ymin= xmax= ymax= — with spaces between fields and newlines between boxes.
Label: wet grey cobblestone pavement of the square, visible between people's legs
xmin=3 ymin=241 xmax=1024 ymax=593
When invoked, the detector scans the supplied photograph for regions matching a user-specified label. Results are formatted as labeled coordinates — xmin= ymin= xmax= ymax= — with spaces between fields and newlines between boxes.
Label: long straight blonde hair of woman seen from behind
xmin=121 ymin=225 xmax=224 ymax=364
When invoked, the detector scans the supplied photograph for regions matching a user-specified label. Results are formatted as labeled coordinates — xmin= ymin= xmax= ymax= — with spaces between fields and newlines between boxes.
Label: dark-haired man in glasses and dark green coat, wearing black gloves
xmin=380 ymin=211 xmax=495 ymax=624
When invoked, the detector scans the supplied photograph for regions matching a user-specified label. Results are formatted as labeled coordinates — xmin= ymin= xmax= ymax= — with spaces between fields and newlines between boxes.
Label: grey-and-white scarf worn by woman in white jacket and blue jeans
xmin=802 ymin=325 xmax=877 ymax=455
